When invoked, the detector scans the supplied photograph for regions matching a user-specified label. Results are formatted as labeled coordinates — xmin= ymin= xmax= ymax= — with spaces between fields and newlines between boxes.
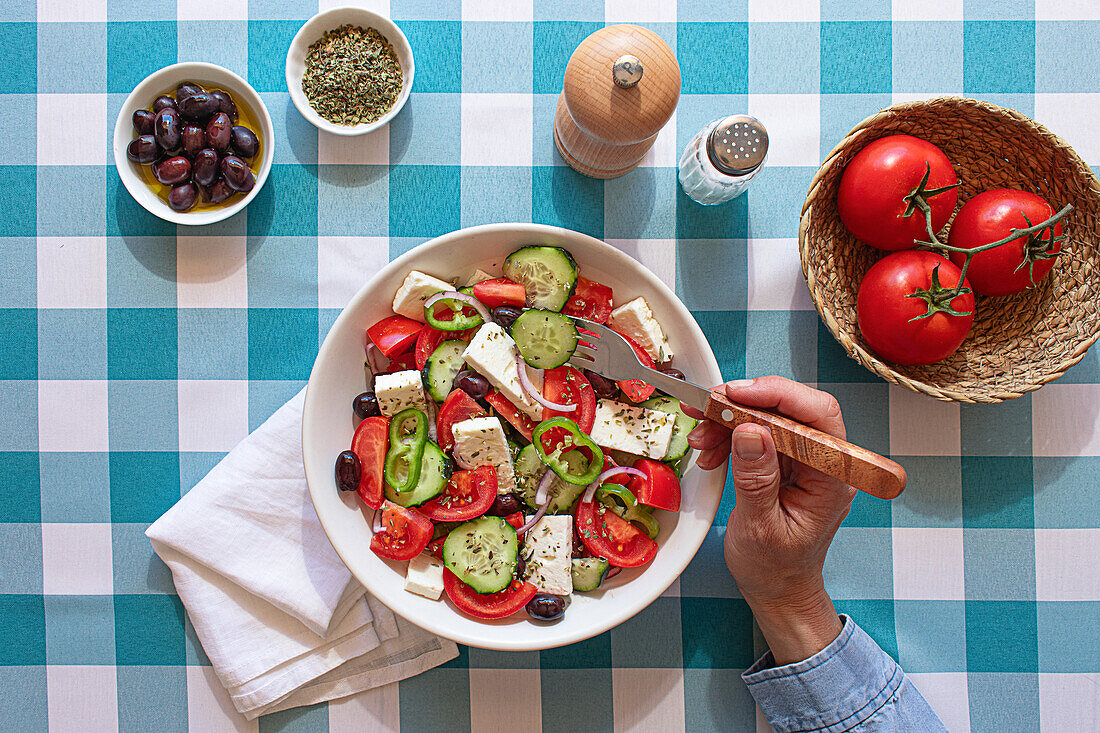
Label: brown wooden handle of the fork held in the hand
xmin=703 ymin=392 xmax=905 ymax=499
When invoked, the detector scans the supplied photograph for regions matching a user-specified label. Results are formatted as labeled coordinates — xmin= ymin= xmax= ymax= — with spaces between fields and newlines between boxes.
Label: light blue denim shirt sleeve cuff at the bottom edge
xmin=741 ymin=614 xmax=947 ymax=733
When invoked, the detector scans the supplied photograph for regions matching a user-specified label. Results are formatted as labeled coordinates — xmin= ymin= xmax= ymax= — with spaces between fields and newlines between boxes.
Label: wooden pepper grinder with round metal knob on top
xmin=553 ymin=25 xmax=680 ymax=178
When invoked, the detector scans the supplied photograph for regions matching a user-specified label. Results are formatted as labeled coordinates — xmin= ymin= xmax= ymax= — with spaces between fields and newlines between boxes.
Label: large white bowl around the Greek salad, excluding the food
xmin=303 ymin=223 xmax=726 ymax=650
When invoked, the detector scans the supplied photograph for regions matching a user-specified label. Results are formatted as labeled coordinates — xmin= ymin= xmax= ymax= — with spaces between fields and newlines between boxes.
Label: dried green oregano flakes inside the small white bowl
xmin=301 ymin=25 xmax=403 ymax=125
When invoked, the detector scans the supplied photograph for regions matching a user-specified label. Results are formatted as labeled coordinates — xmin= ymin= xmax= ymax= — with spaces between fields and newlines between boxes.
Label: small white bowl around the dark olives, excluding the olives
xmin=113 ymin=62 xmax=275 ymax=226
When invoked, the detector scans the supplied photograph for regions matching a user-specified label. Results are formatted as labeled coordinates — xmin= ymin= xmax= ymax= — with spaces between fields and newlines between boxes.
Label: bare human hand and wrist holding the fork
xmin=684 ymin=376 xmax=856 ymax=665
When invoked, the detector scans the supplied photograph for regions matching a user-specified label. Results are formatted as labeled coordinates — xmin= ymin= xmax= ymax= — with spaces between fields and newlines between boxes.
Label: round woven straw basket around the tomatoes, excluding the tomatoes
xmin=799 ymin=97 xmax=1100 ymax=403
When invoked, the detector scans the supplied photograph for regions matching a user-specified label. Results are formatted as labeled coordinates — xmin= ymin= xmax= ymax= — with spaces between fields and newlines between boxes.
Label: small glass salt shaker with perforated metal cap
xmin=679 ymin=114 xmax=768 ymax=206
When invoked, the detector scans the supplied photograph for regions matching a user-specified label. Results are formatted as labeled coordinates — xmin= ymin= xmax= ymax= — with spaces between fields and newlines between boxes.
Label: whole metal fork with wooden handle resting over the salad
xmin=572 ymin=318 xmax=906 ymax=500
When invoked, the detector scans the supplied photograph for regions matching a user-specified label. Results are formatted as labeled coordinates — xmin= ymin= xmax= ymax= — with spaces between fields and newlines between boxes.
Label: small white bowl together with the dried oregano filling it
xmin=286 ymin=8 xmax=415 ymax=135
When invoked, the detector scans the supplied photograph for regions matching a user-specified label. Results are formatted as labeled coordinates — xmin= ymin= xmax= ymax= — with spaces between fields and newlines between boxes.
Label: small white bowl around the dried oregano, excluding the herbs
xmin=286 ymin=8 xmax=416 ymax=135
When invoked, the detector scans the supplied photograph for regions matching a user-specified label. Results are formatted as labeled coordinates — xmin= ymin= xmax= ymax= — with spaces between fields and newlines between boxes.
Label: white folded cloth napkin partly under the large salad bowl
xmin=145 ymin=392 xmax=459 ymax=720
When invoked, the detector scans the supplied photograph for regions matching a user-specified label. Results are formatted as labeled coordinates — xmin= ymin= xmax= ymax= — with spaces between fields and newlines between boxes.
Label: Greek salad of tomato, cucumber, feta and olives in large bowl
xmin=336 ymin=244 xmax=695 ymax=621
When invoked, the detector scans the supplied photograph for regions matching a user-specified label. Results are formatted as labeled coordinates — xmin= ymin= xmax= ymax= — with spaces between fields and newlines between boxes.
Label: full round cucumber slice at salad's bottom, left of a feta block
xmin=443 ymin=516 xmax=519 ymax=593
